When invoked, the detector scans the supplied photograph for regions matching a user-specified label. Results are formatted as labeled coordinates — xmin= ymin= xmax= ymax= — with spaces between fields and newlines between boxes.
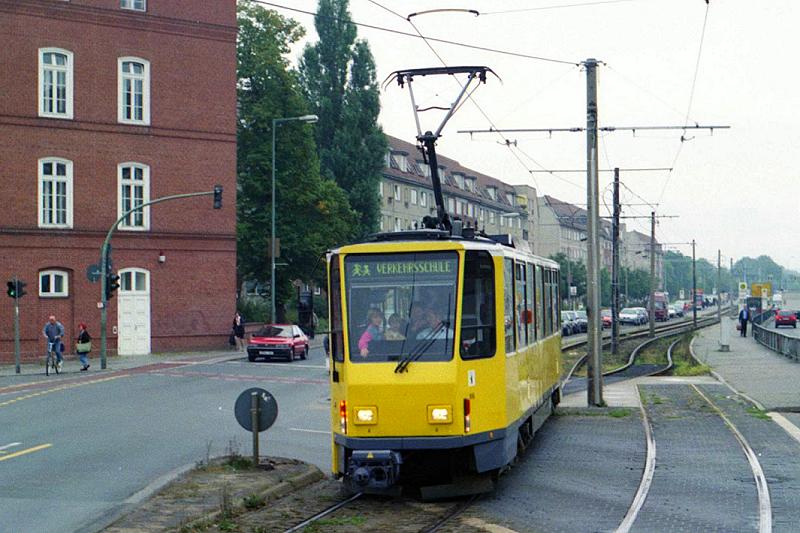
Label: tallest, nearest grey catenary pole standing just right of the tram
xmin=583 ymin=58 xmax=603 ymax=406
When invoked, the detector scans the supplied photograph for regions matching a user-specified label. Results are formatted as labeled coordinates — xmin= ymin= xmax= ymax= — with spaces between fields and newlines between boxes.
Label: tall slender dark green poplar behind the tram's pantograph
xmin=300 ymin=0 xmax=387 ymax=237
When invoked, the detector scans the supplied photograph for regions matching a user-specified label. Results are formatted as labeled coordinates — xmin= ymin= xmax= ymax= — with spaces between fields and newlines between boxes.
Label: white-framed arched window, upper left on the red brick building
xmin=39 ymin=48 xmax=73 ymax=119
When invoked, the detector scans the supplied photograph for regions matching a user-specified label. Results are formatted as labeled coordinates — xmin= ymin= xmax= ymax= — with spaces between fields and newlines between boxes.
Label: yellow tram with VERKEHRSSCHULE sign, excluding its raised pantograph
xmin=328 ymin=233 xmax=561 ymax=493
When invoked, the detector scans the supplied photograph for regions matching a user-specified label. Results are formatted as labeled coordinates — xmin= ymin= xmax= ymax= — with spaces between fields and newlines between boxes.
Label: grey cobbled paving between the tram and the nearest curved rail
xmin=469 ymin=410 xmax=645 ymax=532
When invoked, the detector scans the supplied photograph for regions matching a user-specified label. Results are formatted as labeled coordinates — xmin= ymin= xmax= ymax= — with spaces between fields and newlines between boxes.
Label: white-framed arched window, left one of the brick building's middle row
xmin=38 ymin=157 xmax=72 ymax=228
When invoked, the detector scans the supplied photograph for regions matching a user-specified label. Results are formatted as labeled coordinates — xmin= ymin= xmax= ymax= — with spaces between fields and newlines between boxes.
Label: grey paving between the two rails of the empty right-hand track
xmin=632 ymin=385 xmax=758 ymax=532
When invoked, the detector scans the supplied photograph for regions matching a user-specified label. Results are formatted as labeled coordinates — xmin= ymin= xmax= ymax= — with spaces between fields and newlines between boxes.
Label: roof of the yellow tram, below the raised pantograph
xmin=331 ymin=230 xmax=558 ymax=267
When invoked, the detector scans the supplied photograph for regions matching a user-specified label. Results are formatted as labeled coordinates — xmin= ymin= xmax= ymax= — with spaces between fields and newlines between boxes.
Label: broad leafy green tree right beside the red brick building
xmin=237 ymin=1 xmax=356 ymax=314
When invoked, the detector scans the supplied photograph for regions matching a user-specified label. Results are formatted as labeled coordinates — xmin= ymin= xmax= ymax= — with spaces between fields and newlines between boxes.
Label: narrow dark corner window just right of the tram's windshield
xmin=461 ymin=251 xmax=497 ymax=359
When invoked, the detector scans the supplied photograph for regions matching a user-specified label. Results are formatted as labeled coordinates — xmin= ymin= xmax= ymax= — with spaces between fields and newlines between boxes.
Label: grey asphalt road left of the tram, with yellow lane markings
xmin=0 ymin=348 xmax=330 ymax=532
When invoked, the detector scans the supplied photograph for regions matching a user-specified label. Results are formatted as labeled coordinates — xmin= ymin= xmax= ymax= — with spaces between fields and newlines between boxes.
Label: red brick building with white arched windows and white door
xmin=0 ymin=0 xmax=236 ymax=362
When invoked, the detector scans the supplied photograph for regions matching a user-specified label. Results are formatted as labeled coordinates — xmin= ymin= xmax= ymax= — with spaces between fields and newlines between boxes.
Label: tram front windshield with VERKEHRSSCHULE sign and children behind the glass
xmin=345 ymin=252 xmax=458 ymax=363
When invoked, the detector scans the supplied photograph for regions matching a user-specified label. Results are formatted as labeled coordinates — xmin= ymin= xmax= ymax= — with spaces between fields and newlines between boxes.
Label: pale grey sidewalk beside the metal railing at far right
xmin=694 ymin=318 xmax=800 ymax=411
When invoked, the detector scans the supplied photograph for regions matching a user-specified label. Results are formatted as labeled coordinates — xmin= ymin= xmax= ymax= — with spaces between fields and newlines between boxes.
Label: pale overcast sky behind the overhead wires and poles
xmin=275 ymin=0 xmax=800 ymax=269
